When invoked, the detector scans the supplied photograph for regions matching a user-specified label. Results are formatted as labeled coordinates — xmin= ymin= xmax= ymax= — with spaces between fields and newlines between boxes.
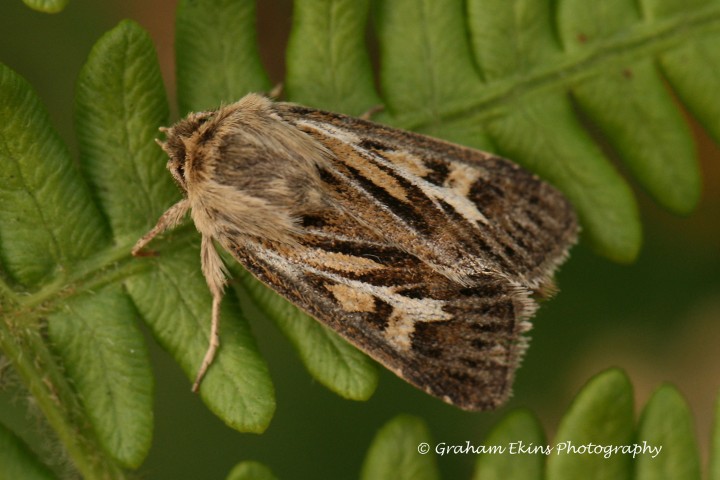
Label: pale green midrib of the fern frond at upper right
xmin=400 ymin=3 xmax=720 ymax=131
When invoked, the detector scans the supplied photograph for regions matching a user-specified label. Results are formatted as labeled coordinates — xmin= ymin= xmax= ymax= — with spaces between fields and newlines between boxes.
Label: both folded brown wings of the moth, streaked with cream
xmin=214 ymin=103 xmax=577 ymax=410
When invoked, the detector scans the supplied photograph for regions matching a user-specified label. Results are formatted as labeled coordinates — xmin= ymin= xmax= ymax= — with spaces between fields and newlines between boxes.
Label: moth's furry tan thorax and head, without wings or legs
xmin=158 ymin=94 xmax=332 ymax=243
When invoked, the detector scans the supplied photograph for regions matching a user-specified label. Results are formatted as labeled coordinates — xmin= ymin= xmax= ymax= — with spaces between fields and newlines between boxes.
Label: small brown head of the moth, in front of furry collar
xmin=155 ymin=111 xmax=215 ymax=192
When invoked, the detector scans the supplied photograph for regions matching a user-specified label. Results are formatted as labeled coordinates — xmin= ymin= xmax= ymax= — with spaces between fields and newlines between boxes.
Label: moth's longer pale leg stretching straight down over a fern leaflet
xmin=192 ymin=235 xmax=226 ymax=392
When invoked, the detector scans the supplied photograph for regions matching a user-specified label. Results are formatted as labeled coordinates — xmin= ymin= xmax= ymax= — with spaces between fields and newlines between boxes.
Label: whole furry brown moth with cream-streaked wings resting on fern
xmin=133 ymin=94 xmax=578 ymax=410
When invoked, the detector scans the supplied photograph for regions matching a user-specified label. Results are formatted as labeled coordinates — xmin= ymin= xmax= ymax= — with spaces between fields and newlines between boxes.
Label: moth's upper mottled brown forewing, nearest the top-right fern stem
xmin=276 ymin=103 xmax=577 ymax=295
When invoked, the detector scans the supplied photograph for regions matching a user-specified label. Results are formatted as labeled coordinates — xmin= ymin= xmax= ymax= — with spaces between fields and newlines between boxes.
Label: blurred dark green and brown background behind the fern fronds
xmin=0 ymin=0 xmax=720 ymax=479
